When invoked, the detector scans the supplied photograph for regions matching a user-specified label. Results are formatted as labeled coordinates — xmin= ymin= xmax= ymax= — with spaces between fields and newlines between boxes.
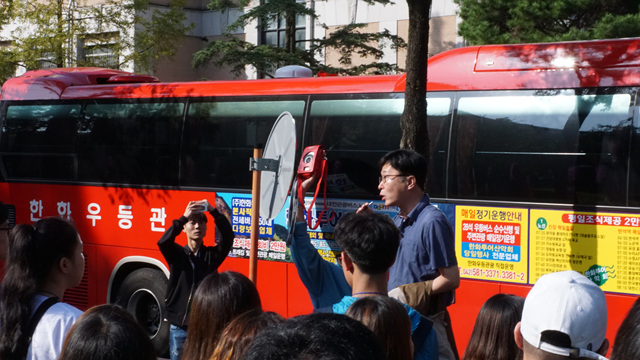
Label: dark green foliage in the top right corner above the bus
xmin=454 ymin=0 xmax=640 ymax=45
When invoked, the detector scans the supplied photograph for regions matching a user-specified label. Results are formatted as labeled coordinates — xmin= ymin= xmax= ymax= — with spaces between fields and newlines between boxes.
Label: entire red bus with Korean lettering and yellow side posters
xmin=0 ymin=39 xmax=640 ymax=353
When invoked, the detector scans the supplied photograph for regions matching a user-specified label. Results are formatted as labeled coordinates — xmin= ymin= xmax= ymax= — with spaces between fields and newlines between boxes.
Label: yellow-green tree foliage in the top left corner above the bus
xmin=0 ymin=0 xmax=191 ymax=76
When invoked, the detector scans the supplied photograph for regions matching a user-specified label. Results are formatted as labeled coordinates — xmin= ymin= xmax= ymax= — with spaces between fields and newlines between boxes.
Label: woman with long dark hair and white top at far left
xmin=0 ymin=218 xmax=84 ymax=359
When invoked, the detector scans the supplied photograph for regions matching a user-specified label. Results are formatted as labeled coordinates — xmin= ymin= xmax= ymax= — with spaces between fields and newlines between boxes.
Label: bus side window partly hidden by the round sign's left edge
xmin=180 ymin=97 xmax=305 ymax=189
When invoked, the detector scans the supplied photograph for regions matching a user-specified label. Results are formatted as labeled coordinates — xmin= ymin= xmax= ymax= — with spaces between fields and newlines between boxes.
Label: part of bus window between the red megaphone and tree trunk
xmin=305 ymin=98 xmax=403 ymax=197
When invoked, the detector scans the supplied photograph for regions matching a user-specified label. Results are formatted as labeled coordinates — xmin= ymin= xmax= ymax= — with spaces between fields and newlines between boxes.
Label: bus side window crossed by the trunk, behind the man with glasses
xmin=305 ymin=94 xmax=451 ymax=197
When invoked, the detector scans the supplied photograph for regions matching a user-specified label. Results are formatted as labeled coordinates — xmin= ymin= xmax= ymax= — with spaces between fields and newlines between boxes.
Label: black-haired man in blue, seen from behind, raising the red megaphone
xmin=290 ymin=177 xmax=438 ymax=360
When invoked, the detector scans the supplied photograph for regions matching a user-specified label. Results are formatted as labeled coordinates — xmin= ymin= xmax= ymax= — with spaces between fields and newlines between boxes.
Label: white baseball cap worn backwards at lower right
xmin=520 ymin=270 xmax=607 ymax=360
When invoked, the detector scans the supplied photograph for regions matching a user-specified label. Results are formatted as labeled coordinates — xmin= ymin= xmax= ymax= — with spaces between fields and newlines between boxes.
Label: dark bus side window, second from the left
xmin=79 ymin=102 xmax=184 ymax=185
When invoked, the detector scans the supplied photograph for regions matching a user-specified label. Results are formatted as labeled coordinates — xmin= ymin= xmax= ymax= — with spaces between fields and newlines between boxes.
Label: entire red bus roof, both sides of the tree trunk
xmin=0 ymin=38 xmax=640 ymax=100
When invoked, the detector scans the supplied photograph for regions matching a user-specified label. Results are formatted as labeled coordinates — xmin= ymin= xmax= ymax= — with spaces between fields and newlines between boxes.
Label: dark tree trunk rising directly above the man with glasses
xmin=400 ymin=0 xmax=431 ymax=161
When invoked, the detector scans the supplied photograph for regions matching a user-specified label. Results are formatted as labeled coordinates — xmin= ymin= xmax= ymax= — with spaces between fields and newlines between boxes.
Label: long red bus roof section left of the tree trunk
xmin=0 ymin=69 xmax=401 ymax=100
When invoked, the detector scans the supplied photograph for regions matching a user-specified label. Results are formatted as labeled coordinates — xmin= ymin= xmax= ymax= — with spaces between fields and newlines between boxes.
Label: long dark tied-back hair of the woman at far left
xmin=0 ymin=217 xmax=78 ymax=359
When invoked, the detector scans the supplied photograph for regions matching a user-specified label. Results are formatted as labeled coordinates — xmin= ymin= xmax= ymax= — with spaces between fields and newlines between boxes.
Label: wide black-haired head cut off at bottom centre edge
xmin=244 ymin=313 xmax=384 ymax=360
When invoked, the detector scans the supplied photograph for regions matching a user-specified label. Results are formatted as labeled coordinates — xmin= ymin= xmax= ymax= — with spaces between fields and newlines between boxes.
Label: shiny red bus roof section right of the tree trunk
xmin=427 ymin=38 xmax=640 ymax=91
